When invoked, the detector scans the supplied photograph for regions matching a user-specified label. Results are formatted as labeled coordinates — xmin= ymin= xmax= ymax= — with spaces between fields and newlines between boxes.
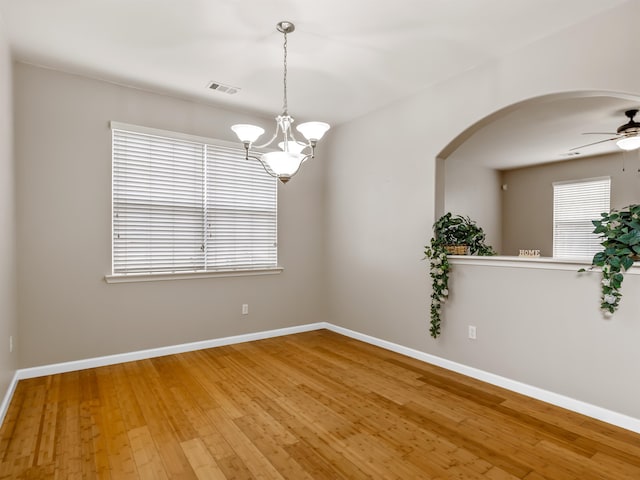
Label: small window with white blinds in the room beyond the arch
xmin=553 ymin=177 xmax=611 ymax=258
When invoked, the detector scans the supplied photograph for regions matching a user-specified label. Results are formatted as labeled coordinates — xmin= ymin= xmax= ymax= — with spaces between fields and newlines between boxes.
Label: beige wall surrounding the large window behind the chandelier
xmin=14 ymin=64 xmax=326 ymax=367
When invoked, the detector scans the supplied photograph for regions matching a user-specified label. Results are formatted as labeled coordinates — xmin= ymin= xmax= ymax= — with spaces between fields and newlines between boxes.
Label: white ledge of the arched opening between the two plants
xmin=449 ymin=255 xmax=640 ymax=275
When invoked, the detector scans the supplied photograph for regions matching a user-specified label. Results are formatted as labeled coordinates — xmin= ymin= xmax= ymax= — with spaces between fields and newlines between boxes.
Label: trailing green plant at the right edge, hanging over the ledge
xmin=579 ymin=205 xmax=640 ymax=316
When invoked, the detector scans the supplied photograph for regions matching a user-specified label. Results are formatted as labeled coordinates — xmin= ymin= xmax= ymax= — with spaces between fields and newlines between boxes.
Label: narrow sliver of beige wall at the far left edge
xmin=0 ymin=18 xmax=19 ymax=394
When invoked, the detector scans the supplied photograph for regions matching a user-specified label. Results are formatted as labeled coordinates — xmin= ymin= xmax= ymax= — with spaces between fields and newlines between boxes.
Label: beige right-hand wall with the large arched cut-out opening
xmin=326 ymin=2 xmax=640 ymax=418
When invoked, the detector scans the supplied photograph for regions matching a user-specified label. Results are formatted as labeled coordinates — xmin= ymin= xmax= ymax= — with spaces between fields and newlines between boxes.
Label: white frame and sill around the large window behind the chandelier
xmin=105 ymin=121 xmax=283 ymax=283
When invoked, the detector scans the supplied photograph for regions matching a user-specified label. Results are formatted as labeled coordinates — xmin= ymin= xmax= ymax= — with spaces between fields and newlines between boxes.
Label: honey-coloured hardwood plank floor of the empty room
xmin=0 ymin=330 xmax=640 ymax=480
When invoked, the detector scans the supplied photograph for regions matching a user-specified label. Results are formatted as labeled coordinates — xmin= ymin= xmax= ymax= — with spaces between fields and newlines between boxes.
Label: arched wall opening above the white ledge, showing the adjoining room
xmin=434 ymin=91 xmax=640 ymax=257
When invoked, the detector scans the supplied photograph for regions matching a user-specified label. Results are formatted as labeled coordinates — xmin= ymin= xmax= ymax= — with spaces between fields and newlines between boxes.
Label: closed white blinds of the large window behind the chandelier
xmin=112 ymin=126 xmax=277 ymax=275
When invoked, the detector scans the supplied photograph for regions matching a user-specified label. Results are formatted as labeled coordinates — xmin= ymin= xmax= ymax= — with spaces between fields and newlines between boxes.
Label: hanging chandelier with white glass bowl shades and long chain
xmin=231 ymin=21 xmax=330 ymax=183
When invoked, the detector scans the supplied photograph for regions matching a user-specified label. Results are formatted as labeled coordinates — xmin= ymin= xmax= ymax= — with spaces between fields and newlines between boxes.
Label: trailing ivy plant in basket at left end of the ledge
xmin=424 ymin=213 xmax=496 ymax=338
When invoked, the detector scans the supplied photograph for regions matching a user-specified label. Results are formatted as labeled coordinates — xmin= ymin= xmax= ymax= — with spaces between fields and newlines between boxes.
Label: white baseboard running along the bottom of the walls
xmin=0 ymin=322 xmax=640 ymax=433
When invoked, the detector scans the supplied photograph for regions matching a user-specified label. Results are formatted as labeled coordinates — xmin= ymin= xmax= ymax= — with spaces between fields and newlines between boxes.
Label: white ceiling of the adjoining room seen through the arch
xmin=448 ymin=95 xmax=640 ymax=169
